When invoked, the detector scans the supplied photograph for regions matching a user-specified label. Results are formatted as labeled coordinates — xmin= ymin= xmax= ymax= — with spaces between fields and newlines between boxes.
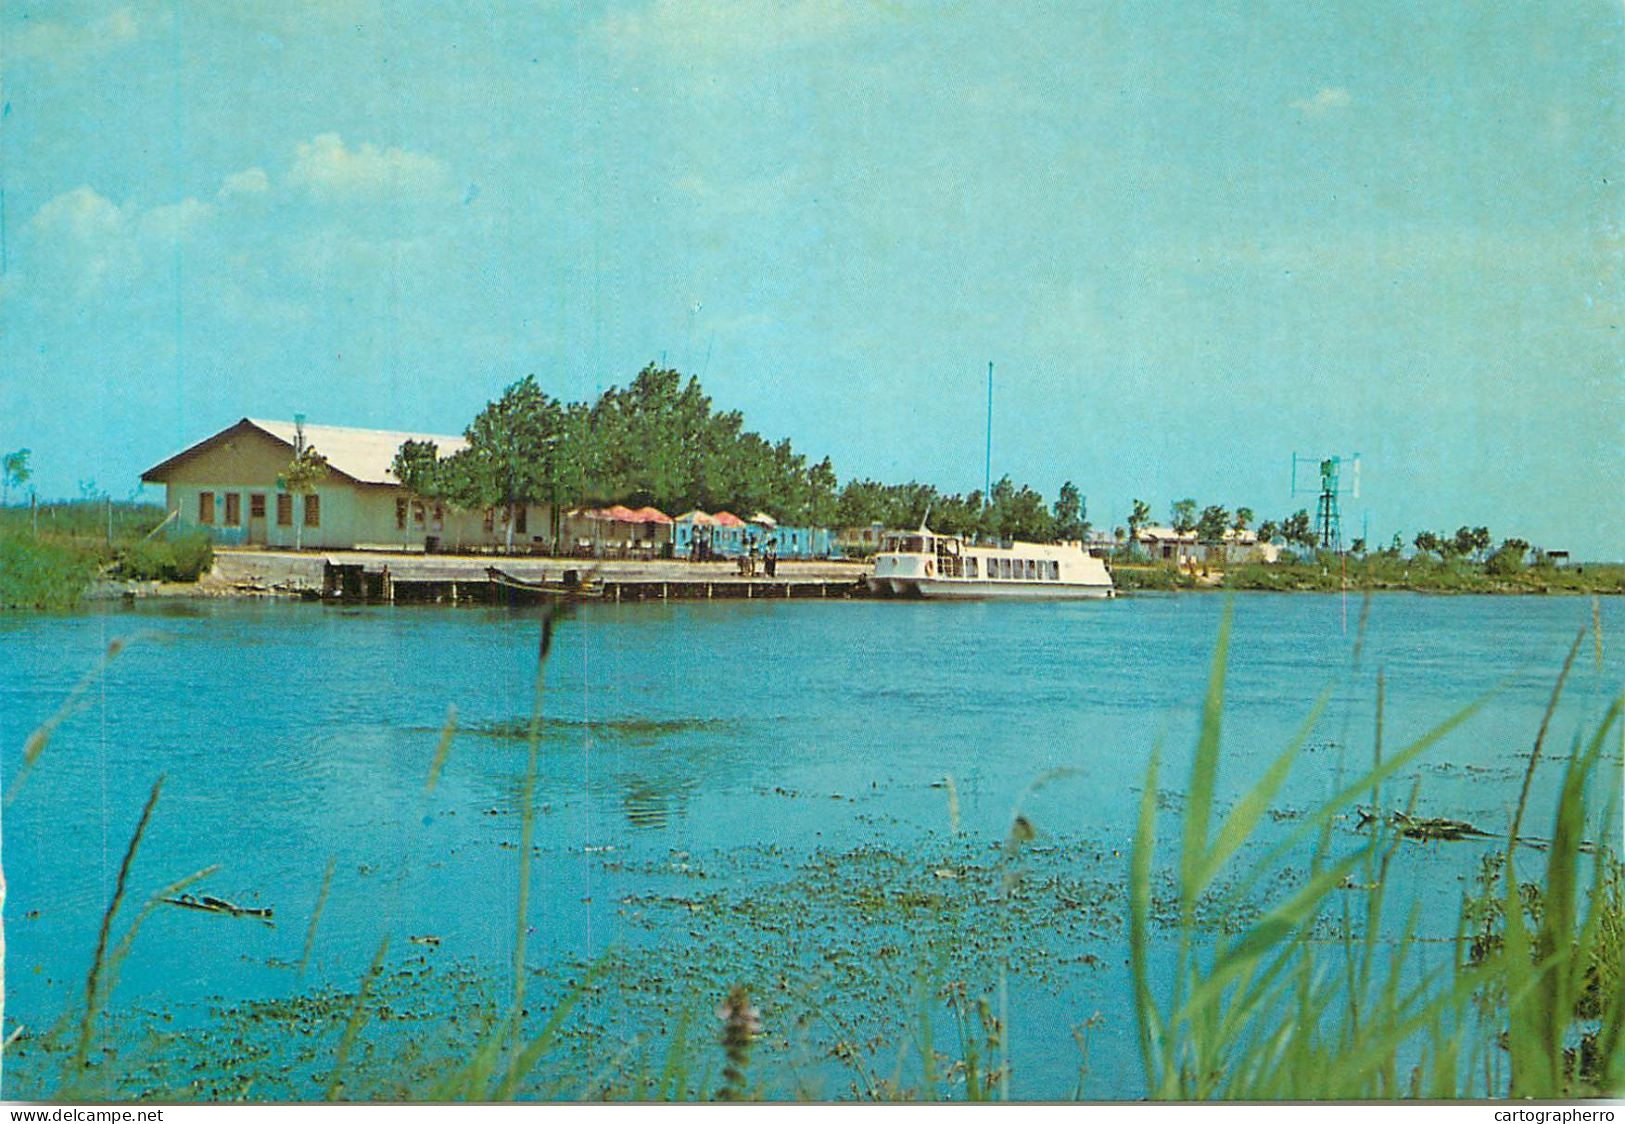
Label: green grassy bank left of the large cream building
xmin=0 ymin=500 xmax=215 ymax=611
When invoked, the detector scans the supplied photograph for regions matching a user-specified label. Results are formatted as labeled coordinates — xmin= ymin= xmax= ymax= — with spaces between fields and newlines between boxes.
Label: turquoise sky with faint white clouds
xmin=0 ymin=0 xmax=1625 ymax=559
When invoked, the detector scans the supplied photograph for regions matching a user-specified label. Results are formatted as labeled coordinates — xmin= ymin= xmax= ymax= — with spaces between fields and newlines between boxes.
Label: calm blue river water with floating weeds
xmin=0 ymin=594 xmax=1625 ymax=1096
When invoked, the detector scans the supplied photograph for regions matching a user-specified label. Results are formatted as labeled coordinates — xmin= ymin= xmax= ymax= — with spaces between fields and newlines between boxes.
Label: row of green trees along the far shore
xmin=260 ymin=364 xmax=1553 ymax=565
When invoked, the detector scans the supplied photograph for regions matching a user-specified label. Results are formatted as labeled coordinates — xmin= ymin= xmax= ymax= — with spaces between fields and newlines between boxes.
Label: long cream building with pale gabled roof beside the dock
xmin=141 ymin=417 xmax=551 ymax=551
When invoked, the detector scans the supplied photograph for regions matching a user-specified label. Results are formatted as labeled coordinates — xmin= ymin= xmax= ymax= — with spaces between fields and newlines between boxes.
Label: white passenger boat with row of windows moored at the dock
xmin=866 ymin=526 xmax=1115 ymax=599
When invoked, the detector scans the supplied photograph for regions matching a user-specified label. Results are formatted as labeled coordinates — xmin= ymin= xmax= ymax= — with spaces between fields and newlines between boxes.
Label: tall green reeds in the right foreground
xmin=1129 ymin=609 xmax=1622 ymax=1100
